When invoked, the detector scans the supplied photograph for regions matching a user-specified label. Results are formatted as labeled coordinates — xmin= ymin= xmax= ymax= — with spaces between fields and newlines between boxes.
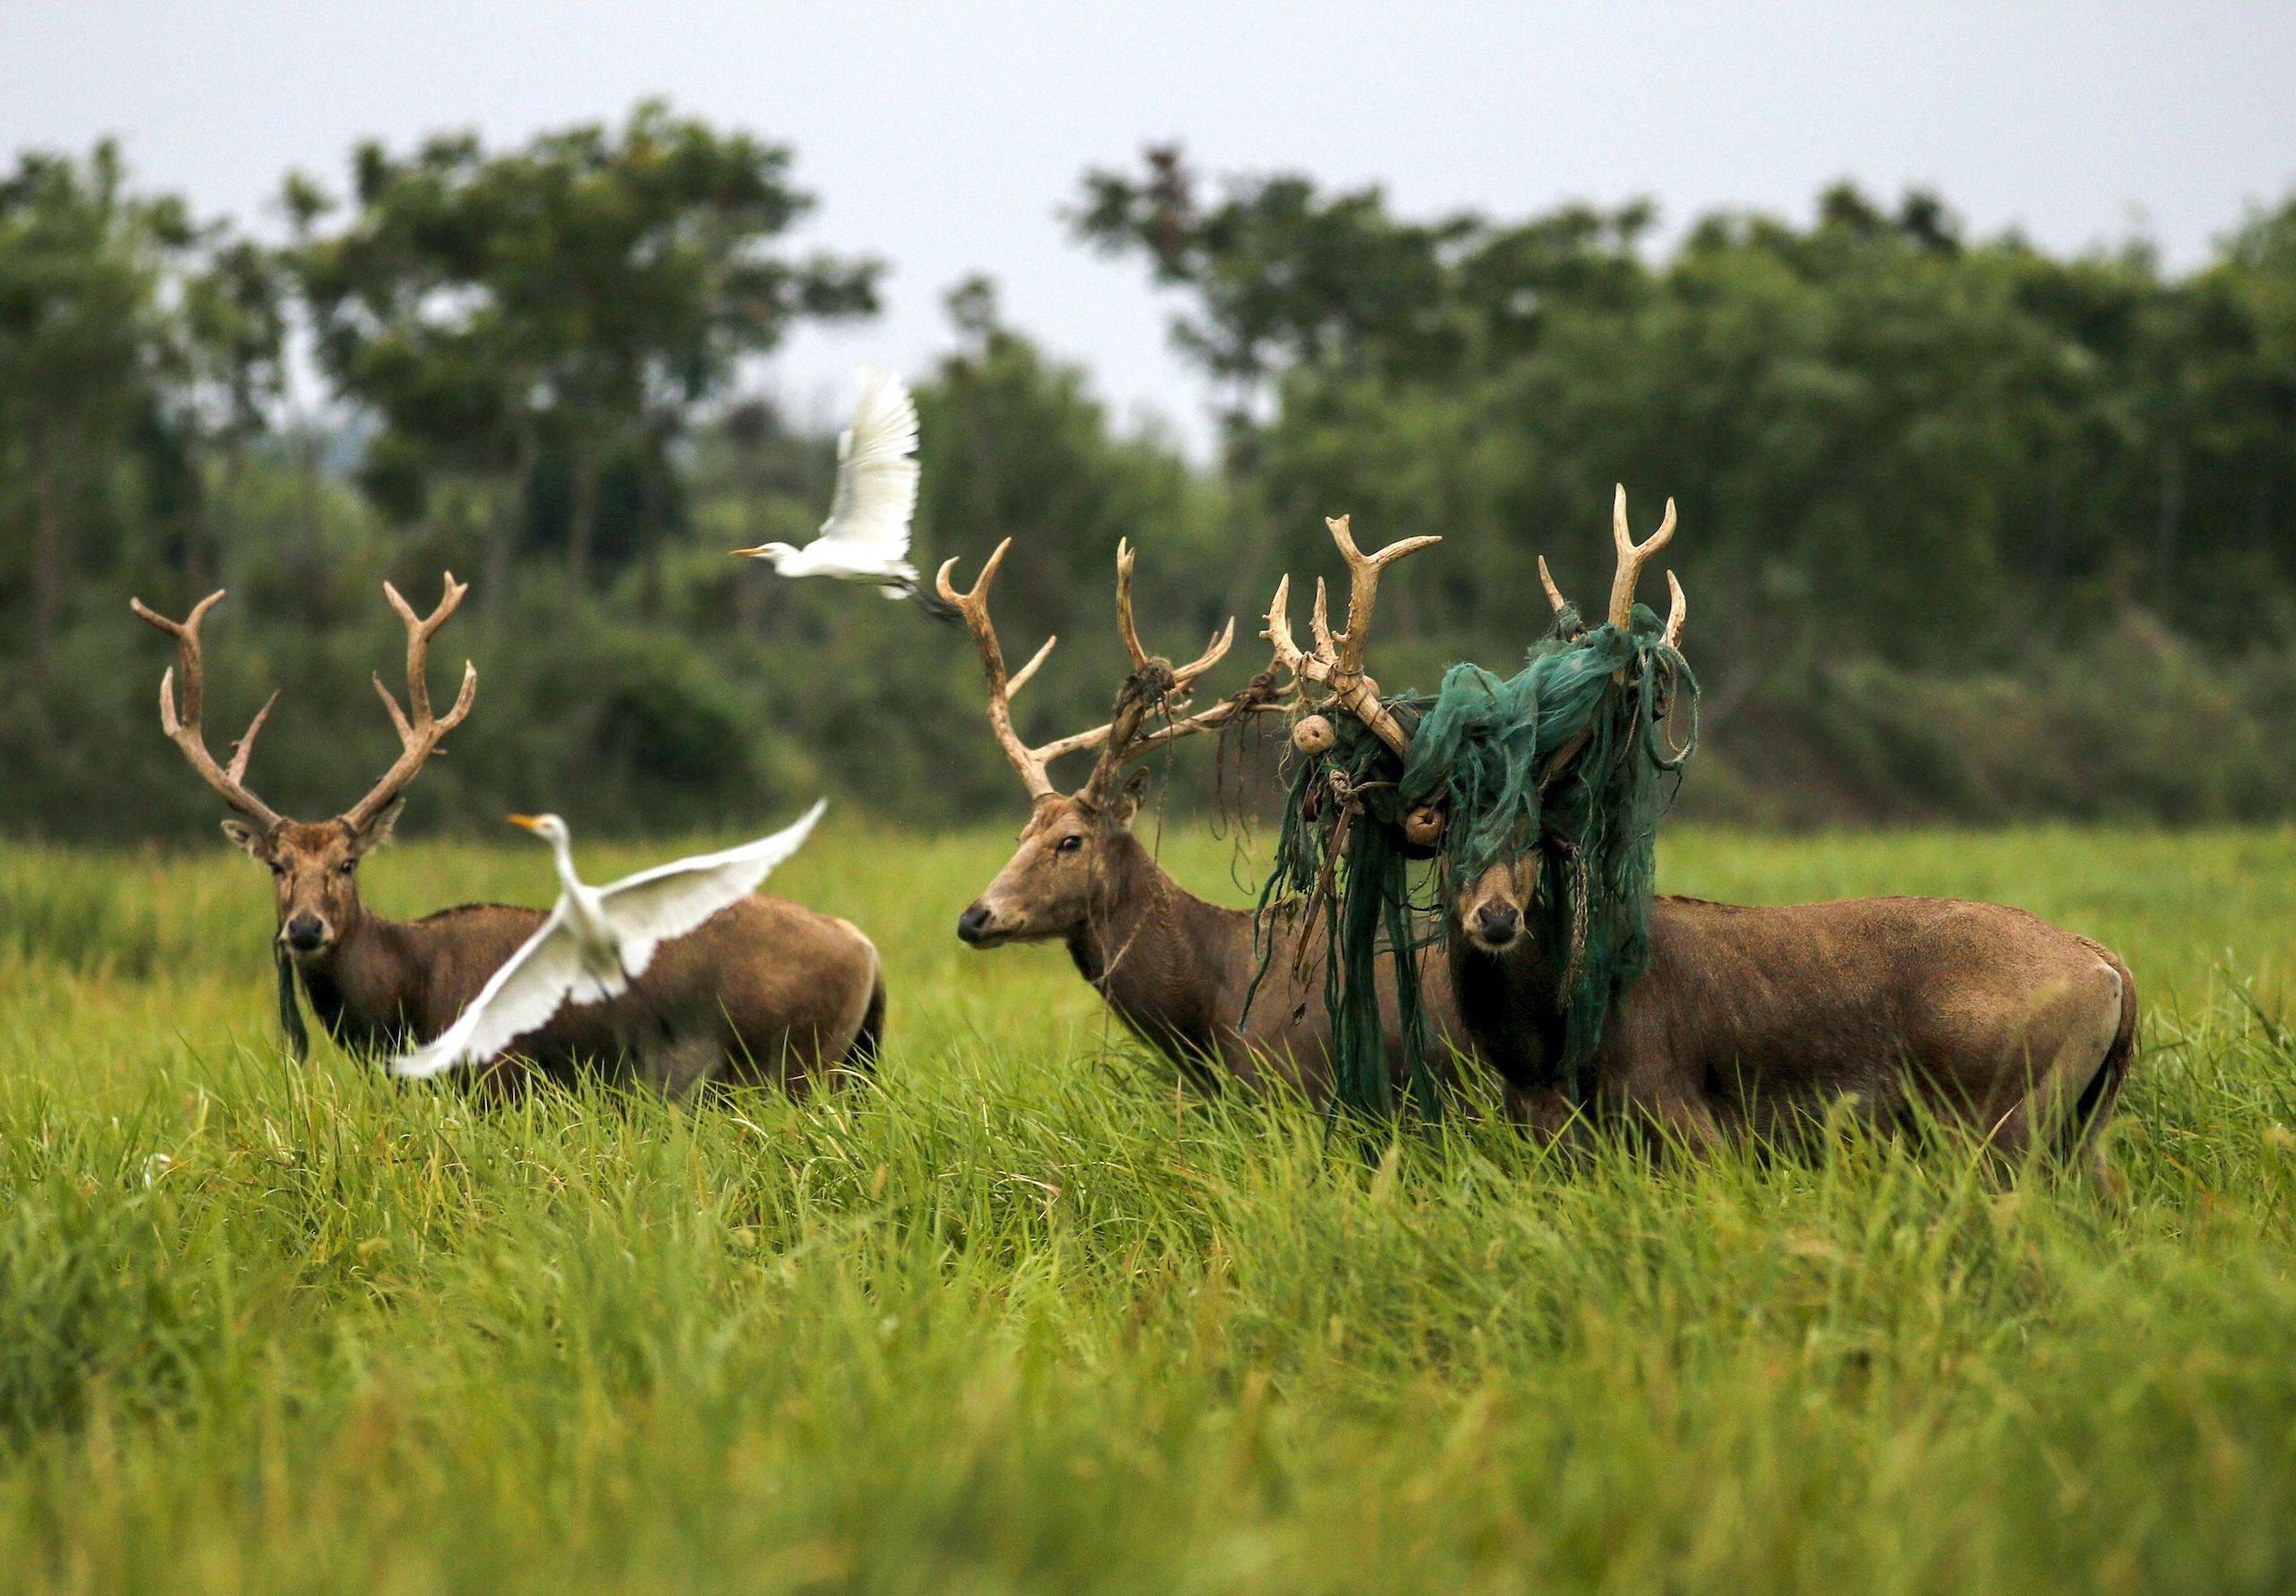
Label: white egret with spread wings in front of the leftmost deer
xmin=390 ymin=802 xmax=829 ymax=1077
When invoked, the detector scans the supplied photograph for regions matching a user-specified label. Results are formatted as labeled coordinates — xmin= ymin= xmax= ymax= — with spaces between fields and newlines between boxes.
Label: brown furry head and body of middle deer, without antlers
xmin=958 ymin=794 xmax=1463 ymax=1105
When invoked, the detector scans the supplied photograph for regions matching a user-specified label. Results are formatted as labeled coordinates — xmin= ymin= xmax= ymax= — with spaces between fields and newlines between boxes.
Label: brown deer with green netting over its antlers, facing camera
xmin=1294 ymin=487 xmax=2137 ymax=1190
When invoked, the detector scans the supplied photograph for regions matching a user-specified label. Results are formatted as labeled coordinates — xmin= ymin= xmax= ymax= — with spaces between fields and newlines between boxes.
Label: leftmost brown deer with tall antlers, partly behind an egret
xmin=133 ymin=574 xmax=884 ymax=1093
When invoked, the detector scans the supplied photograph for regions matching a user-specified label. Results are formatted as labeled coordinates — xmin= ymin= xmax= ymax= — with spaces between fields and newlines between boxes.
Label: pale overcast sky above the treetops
xmin=0 ymin=0 xmax=2296 ymax=452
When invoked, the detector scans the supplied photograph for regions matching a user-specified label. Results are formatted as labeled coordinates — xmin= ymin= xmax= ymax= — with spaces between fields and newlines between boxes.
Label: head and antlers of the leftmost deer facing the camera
xmin=131 ymin=572 xmax=477 ymax=960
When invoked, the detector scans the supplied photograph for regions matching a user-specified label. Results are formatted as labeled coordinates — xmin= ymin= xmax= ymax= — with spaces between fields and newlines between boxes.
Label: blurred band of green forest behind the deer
xmin=0 ymin=106 xmax=2296 ymax=838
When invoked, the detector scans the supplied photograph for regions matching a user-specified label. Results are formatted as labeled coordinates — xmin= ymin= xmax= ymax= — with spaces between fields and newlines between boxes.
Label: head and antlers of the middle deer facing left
xmin=935 ymin=537 xmax=1279 ymax=949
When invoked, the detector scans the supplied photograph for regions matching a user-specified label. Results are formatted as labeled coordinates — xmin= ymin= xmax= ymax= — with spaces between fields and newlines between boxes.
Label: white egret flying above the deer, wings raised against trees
xmin=735 ymin=368 xmax=958 ymax=620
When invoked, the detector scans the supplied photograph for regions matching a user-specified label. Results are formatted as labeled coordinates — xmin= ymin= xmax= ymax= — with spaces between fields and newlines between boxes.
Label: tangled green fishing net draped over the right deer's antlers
xmin=1258 ymin=604 xmax=1697 ymax=1114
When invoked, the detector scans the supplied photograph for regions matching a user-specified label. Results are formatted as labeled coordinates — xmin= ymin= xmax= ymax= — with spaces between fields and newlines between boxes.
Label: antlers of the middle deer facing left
xmin=932 ymin=537 xmax=1272 ymax=799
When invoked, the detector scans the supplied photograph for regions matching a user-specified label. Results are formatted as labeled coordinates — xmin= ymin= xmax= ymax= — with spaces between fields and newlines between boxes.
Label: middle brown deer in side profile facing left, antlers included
xmin=935 ymin=537 xmax=1460 ymax=1105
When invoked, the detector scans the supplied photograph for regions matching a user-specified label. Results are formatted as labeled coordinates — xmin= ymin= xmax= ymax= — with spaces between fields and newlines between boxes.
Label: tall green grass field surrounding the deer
xmin=0 ymin=829 xmax=2296 ymax=1593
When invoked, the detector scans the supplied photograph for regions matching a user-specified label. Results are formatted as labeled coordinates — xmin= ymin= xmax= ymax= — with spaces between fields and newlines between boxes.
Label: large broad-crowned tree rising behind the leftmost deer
xmin=290 ymin=101 xmax=879 ymax=590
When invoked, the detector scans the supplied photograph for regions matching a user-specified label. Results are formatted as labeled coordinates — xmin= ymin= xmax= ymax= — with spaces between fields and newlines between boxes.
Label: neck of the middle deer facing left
xmin=1067 ymin=834 xmax=1251 ymax=1052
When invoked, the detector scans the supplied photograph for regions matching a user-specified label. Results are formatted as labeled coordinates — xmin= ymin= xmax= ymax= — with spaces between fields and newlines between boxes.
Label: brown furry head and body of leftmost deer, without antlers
xmin=225 ymin=813 xmax=884 ymax=1096
